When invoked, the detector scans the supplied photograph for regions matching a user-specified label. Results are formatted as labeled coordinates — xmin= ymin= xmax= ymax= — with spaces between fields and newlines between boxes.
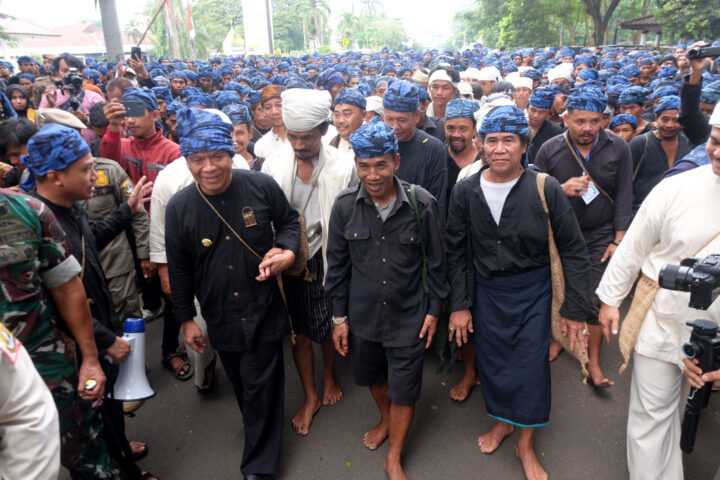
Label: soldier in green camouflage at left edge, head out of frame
xmin=0 ymin=190 xmax=120 ymax=479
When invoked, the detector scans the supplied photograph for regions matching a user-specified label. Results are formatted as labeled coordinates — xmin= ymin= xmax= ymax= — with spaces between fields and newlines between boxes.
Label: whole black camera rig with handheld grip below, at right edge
xmin=658 ymin=255 xmax=720 ymax=453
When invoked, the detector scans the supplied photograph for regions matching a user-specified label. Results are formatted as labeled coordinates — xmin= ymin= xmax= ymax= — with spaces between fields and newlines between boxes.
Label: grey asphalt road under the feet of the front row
xmin=118 ymin=321 xmax=720 ymax=480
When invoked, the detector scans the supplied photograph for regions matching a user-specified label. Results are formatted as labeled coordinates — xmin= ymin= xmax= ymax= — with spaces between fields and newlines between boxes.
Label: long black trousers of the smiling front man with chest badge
xmin=218 ymin=340 xmax=285 ymax=475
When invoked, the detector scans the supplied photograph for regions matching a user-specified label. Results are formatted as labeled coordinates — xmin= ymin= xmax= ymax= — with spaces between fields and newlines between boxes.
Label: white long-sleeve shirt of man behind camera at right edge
xmin=597 ymin=165 xmax=720 ymax=368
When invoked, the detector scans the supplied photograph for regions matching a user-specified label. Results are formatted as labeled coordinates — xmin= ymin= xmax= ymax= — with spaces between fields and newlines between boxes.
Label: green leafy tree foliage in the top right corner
xmin=652 ymin=0 xmax=720 ymax=40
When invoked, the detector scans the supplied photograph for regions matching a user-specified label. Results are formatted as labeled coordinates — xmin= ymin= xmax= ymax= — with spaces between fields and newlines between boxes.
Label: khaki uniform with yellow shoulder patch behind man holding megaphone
xmin=80 ymin=158 xmax=154 ymax=319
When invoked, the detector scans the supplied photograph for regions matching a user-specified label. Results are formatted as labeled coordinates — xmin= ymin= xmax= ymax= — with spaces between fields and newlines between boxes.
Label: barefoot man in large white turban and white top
xmin=262 ymin=89 xmax=358 ymax=435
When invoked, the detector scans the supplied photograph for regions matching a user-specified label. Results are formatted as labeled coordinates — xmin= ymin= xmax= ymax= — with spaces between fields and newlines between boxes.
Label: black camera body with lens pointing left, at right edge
xmin=659 ymin=255 xmax=720 ymax=310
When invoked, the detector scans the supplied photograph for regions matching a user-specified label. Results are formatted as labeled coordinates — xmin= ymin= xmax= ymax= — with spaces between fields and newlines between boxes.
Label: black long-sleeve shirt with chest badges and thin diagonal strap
xmin=165 ymin=170 xmax=300 ymax=351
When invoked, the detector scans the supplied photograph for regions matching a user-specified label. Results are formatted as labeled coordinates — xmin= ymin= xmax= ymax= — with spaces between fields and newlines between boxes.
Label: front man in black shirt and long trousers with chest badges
xmin=165 ymin=108 xmax=300 ymax=480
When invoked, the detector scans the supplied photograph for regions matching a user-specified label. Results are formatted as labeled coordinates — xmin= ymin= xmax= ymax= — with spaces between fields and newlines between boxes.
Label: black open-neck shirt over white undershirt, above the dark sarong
xmin=445 ymin=167 xmax=590 ymax=321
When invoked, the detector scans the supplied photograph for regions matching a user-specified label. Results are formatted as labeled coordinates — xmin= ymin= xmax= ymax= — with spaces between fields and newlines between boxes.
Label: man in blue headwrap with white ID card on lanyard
xmin=535 ymin=88 xmax=632 ymax=387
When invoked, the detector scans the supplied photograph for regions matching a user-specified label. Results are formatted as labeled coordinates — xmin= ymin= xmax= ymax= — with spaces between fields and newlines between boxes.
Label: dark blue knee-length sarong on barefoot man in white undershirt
xmin=473 ymin=267 xmax=552 ymax=427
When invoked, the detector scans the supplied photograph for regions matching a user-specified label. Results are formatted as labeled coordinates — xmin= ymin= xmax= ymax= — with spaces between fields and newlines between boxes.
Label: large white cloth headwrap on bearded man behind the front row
xmin=280 ymin=88 xmax=332 ymax=132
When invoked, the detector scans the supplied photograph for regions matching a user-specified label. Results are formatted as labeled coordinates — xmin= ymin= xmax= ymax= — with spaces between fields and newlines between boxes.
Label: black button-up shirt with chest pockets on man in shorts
xmin=325 ymin=179 xmax=449 ymax=347
